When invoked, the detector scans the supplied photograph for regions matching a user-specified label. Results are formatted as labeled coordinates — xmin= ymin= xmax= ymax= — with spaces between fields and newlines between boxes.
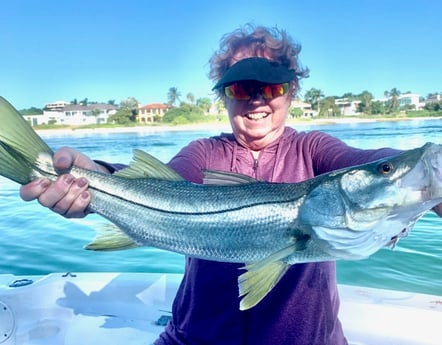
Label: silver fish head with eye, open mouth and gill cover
xmin=299 ymin=143 xmax=442 ymax=259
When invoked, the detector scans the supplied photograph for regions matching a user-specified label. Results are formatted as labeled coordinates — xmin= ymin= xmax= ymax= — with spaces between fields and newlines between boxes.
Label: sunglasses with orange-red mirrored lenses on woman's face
xmin=224 ymin=82 xmax=289 ymax=101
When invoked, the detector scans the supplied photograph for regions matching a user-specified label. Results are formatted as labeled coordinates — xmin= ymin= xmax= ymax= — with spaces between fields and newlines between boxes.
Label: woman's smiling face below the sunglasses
xmin=225 ymin=81 xmax=292 ymax=151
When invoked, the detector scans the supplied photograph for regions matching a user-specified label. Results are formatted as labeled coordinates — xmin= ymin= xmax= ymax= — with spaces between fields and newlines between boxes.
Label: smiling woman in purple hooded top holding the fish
xmin=21 ymin=25 xmax=440 ymax=345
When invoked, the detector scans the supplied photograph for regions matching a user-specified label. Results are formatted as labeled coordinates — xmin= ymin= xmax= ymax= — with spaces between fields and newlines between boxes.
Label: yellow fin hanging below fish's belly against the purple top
xmin=238 ymin=243 xmax=299 ymax=310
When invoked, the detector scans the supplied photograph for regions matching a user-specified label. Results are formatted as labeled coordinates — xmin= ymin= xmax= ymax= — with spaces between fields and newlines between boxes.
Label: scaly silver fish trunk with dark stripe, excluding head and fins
xmin=88 ymin=169 xmax=322 ymax=262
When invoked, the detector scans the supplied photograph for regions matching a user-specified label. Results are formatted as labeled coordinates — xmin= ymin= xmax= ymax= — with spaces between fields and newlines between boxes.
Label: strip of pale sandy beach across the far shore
xmin=35 ymin=117 xmax=442 ymax=135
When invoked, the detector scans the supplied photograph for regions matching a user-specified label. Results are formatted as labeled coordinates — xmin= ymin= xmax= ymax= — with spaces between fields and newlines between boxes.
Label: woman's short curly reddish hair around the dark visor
xmin=209 ymin=24 xmax=309 ymax=96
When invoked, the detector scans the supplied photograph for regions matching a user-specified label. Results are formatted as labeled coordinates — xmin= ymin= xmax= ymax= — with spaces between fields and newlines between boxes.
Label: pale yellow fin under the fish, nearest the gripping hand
xmin=85 ymin=223 xmax=139 ymax=251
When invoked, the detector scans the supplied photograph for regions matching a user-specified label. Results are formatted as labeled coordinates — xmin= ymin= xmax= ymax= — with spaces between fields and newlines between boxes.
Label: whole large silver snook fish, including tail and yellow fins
xmin=0 ymin=99 xmax=442 ymax=309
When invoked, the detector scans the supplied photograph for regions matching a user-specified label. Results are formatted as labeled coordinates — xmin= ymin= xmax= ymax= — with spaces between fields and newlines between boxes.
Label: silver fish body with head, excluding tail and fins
xmin=79 ymin=140 xmax=442 ymax=264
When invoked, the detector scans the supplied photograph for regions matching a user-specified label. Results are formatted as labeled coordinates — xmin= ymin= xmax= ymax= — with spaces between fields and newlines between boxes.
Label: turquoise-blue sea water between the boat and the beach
xmin=0 ymin=119 xmax=442 ymax=295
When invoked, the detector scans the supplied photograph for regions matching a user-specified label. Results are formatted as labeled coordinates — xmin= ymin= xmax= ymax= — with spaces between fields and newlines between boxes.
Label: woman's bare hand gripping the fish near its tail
xmin=20 ymin=147 xmax=109 ymax=218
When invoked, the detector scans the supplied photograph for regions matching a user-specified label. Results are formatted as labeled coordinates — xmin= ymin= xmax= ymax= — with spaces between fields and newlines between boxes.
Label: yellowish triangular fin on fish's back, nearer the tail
xmin=114 ymin=149 xmax=183 ymax=181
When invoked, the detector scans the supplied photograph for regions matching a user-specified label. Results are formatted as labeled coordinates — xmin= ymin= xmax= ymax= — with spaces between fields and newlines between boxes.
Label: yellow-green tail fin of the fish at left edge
xmin=0 ymin=97 xmax=53 ymax=184
